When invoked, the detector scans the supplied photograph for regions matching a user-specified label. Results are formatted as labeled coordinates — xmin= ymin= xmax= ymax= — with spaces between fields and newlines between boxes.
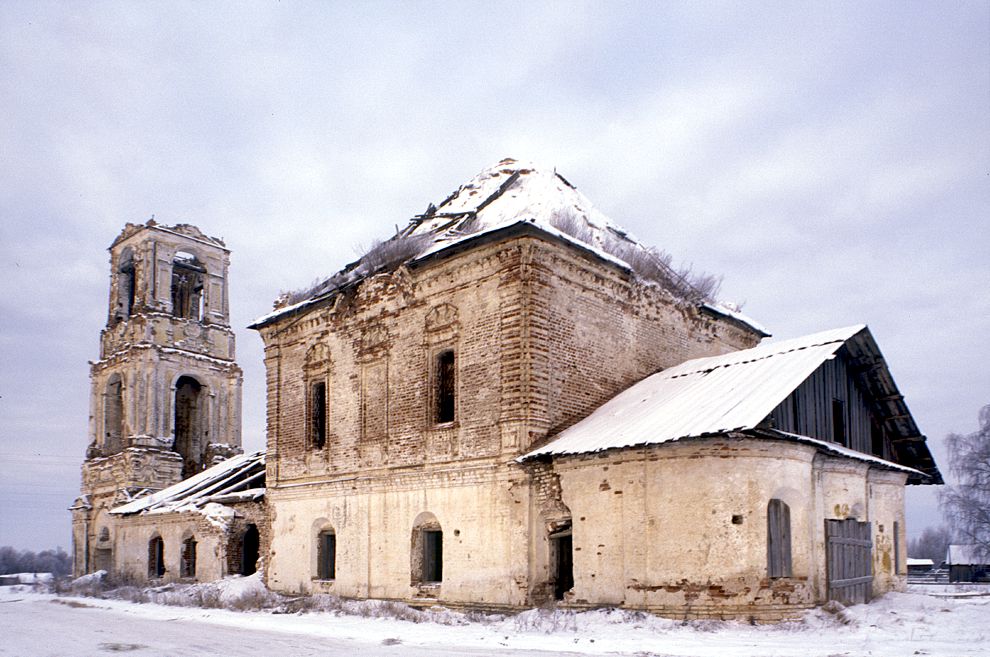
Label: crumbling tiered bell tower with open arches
xmin=71 ymin=220 xmax=242 ymax=575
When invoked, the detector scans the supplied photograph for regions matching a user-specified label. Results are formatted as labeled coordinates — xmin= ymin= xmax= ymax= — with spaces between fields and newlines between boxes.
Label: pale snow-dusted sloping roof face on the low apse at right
xmin=522 ymin=324 xmax=866 ymax=459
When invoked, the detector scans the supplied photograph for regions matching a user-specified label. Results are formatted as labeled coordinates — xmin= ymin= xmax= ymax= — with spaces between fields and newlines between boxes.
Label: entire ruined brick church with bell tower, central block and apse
xmin=73 ymin=160 xmax=941 ymax=620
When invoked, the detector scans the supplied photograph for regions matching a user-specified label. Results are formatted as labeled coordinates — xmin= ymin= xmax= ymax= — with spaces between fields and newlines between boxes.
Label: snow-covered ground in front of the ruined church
xmin=0 ymin=582 xmax=990 ymax=657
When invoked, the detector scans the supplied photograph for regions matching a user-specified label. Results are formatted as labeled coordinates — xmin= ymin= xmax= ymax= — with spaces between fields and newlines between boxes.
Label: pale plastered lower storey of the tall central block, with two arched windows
xmin=267 ymin=467 xmax=528 ymax=607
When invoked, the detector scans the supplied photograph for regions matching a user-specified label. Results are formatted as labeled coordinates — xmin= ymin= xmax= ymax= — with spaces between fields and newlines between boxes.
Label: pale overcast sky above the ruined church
xmin=0 ymin=1 xmax=990 ymax=549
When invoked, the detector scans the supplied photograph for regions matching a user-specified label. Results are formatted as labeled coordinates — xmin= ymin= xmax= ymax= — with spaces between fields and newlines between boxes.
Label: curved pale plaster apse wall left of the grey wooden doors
xmin=554 ymin=439 xmax=815 ymax=620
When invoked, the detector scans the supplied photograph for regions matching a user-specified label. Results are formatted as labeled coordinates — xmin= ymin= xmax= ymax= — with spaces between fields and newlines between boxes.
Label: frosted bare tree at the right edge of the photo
xmin=940 ymin=405 xmax=990 ymax=559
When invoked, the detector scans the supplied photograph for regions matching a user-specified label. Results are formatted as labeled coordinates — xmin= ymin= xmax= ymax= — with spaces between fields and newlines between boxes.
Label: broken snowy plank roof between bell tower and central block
xmin=110 ymin=451 xmax=265 ymax=515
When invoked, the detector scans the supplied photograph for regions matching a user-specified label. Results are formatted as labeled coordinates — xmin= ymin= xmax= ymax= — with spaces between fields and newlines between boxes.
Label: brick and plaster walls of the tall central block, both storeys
xmin=260 ymin=236 xmax=757 ymax=607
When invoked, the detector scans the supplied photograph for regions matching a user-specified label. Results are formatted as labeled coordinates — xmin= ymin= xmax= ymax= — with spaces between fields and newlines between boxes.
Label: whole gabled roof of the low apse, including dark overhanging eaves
xmin=520 ymin=325 xmax=942 ymax=484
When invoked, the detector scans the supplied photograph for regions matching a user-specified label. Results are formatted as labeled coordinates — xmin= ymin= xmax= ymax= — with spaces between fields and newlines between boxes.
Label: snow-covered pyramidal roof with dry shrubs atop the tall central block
xmin=251 ymin=158 xmax=769 ymax=335
